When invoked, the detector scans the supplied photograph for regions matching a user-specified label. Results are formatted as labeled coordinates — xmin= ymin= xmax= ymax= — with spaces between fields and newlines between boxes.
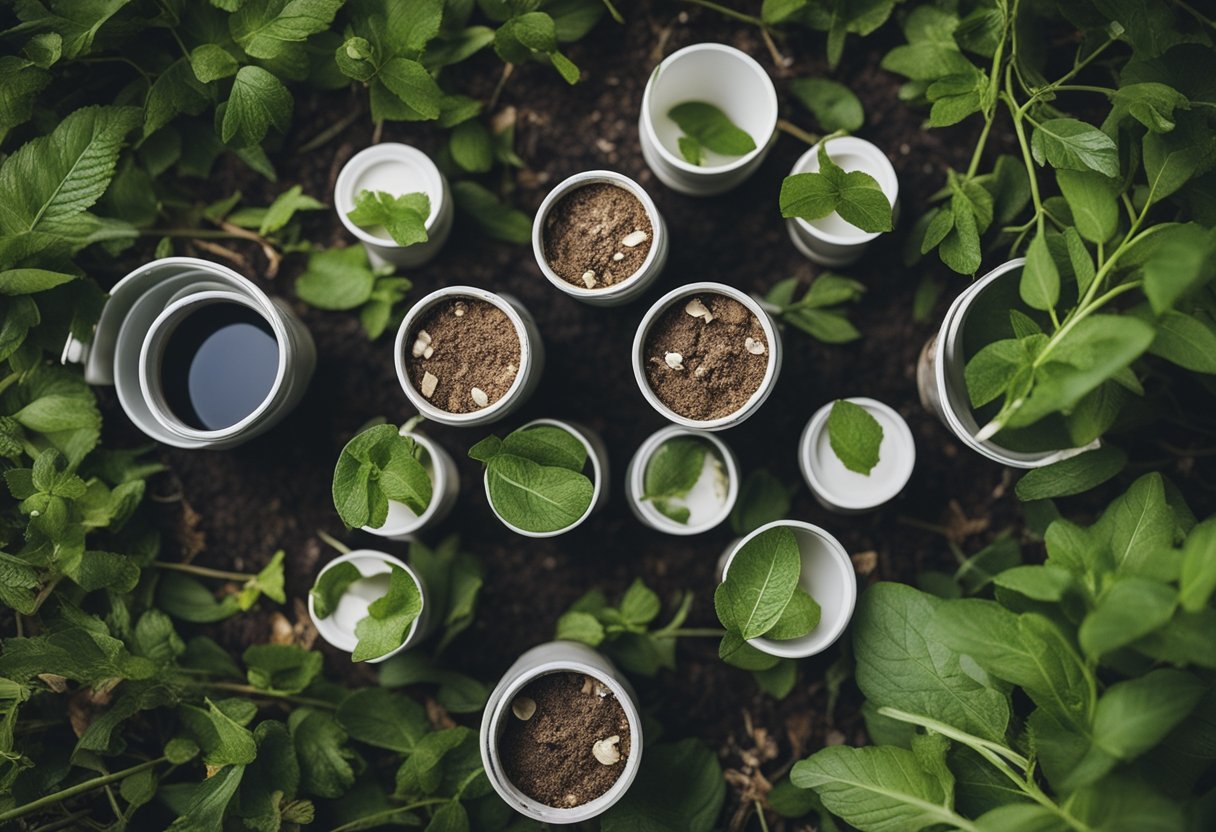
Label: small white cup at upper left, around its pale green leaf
xmin=333 ymin=141 xmax=455 ymax=269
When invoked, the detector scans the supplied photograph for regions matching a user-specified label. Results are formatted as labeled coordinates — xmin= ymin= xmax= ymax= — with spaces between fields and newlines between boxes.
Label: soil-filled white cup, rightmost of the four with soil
xmin=634 ymin=282 xmax=781 ymax=431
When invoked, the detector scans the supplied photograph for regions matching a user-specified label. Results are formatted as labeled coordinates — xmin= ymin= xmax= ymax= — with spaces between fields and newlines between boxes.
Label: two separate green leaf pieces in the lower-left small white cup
xmin=311 ymin=561 xmax=422 ymax=662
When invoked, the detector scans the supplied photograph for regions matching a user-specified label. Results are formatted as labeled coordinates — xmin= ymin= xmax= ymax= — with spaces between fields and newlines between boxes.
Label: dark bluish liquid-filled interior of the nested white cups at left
xmin=161 ymin=303 xmax=278 ymax=431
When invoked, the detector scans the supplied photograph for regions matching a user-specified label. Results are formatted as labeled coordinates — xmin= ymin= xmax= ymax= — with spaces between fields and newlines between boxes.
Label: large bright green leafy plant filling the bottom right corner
xmin=792 ymin=474 xmax=1216 ymax=831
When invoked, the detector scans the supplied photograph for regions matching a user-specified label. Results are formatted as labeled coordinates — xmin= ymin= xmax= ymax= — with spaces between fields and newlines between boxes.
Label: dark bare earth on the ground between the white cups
xmin=88 ymin=2 xmax=1216 ymax=828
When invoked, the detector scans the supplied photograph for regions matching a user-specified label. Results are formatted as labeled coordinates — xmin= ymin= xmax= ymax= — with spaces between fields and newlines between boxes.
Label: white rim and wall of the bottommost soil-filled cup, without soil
xmin=479 ymin=641 xmax=642 ymax=823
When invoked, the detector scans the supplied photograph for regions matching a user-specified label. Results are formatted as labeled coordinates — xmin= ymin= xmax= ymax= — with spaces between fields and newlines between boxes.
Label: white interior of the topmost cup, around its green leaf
xmin=644 ymin=44 xmax=777 ymax=172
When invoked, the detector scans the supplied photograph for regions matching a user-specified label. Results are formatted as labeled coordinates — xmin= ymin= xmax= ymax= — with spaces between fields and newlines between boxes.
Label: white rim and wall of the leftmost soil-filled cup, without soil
xmin=393 ymin=286 xmax=545 ymax=427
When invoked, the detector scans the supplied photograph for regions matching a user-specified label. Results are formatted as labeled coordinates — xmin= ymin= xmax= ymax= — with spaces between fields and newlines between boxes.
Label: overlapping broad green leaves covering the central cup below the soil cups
xmin=468 ymin=425 xmax=595 ymax=533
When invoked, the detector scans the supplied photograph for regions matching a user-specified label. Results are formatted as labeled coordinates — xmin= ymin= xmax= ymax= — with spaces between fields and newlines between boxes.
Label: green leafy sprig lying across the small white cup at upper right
xmin=781 ymin=139 xmax=893 ymax=232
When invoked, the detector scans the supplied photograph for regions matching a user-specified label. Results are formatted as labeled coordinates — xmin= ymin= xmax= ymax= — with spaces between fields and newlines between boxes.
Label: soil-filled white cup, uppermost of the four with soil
xmin=533 ymin=170 xmax=668 ymax=307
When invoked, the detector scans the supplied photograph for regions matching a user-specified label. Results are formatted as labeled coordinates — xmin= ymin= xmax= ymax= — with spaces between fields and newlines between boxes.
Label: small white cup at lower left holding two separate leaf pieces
xmin=308 ymin=549 xmax=429 ymax=664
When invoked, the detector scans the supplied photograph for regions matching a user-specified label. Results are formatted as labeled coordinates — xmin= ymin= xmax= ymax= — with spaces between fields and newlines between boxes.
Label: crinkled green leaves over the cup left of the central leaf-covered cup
xmin=333 ymin=425 xmax=432 ymax=528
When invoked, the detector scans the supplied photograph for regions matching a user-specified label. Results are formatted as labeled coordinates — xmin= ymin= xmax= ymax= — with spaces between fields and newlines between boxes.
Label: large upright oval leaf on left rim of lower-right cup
xmin=714 ymin=527 xmax=801 ymax=640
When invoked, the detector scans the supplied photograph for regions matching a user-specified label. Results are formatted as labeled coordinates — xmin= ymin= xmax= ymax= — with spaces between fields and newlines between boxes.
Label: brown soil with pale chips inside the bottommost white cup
xmin=499 ymin=673 xmax=630 ymax=809
